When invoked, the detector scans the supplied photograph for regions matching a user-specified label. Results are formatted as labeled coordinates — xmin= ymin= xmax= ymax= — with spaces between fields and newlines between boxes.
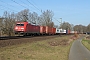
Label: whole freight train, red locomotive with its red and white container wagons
xmin=14 ymin=22 xmax=75 ymax=35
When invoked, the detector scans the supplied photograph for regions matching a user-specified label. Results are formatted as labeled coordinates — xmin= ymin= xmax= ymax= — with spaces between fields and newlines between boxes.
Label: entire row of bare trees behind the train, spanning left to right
xmin=0 ymin=9 xmax=90 ymax=36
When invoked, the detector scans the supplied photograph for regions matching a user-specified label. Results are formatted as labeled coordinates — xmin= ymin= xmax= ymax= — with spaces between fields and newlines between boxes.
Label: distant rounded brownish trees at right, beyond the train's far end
xmin=60 ymin=22 xmax=90 ymax=33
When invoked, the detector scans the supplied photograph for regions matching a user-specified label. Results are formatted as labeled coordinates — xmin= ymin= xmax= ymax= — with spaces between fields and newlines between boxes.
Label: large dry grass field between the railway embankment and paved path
xmin=0 ymin=36 xmax=71 ymax=60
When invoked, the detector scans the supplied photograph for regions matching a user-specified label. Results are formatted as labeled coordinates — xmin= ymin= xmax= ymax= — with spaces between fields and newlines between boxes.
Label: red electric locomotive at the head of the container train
xmin=14 ymin=22 xmax=40 ymax=35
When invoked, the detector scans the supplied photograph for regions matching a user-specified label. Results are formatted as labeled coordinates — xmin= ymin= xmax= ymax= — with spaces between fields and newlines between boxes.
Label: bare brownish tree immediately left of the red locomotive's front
xmin=2 ymin=11 xmax=15 ymax=36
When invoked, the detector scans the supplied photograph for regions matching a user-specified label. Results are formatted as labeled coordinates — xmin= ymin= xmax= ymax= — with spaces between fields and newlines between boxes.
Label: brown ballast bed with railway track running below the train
xmin=0 ymin=35 xmax=60 ymax=48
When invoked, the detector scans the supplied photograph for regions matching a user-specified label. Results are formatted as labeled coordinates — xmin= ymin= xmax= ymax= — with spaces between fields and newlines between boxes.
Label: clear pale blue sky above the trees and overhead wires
xmin=0 ymin=0 xmax=90 ymax=26
